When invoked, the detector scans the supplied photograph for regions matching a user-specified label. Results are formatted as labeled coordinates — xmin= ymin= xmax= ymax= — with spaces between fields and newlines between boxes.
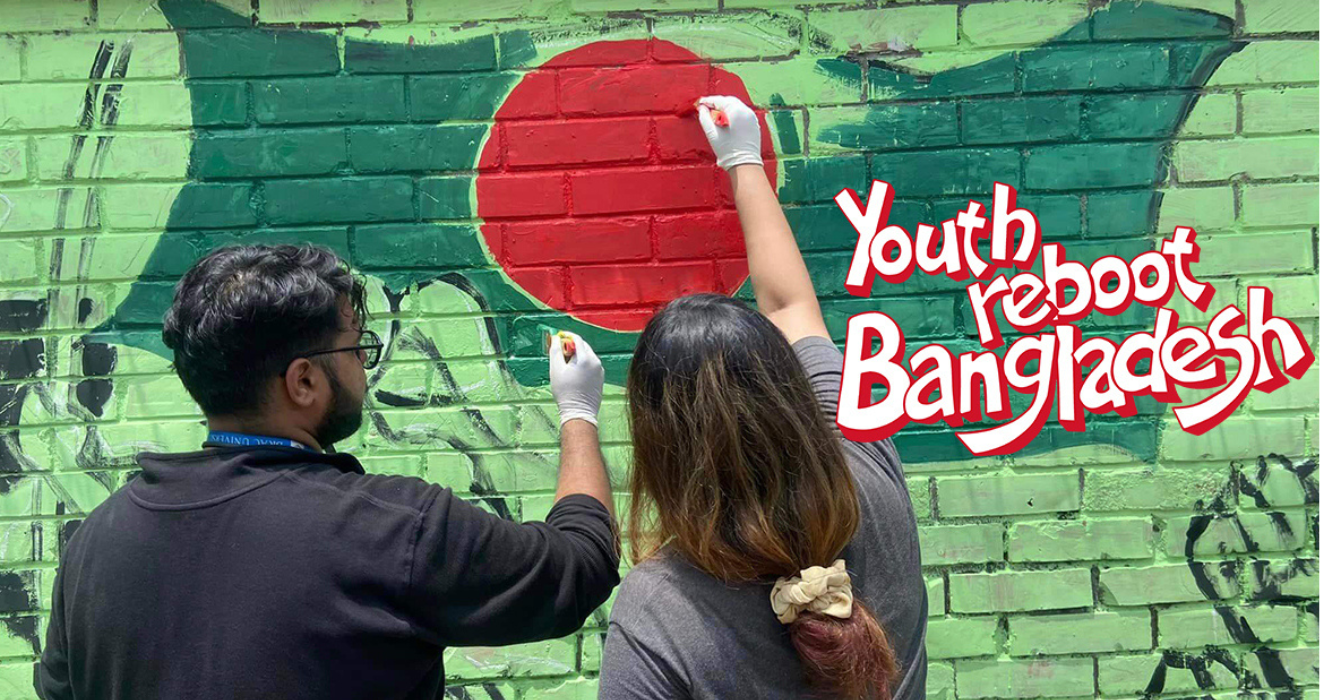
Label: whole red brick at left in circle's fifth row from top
xmin=504 ymin=218 xmax=651 ymax=265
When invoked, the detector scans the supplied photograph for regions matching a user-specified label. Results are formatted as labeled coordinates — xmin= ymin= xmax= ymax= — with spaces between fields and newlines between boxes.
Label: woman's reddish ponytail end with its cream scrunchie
xmin=770 ymin=560 xmax=899 ymax=700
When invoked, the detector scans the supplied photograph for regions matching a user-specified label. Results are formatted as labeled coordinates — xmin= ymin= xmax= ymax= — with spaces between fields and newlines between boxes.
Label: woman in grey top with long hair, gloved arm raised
xmin=601 ymin=96 xmax=927 ymax=700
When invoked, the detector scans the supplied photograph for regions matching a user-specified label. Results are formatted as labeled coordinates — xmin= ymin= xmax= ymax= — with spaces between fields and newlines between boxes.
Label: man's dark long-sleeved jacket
xmin=36 ymin=448 xmax=619 ymax=700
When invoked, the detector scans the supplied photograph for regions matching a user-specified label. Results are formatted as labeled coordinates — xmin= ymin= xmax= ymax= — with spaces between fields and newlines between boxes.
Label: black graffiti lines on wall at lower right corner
xmin=1146 ymin=453 xmax=1317 ymax=699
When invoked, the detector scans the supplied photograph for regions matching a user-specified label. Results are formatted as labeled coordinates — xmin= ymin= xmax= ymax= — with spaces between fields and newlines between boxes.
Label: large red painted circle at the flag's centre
xmin=477 ymin=40 xmax=776 ymax=330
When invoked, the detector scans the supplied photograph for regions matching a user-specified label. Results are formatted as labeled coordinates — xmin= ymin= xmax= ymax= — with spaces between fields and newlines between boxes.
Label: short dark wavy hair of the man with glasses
xmin=162 ymin=246 xmax=367 ymax=416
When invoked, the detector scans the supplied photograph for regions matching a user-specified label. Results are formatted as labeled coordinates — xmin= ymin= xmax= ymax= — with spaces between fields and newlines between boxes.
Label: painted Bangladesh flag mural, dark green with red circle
xmin=98 ymin=0 xmax=1237 ymax=461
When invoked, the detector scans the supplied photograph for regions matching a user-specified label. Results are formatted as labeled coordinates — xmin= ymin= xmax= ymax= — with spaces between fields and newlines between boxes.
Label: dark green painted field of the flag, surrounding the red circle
xmin=98 ymin=0 xmax=1237 ymax=462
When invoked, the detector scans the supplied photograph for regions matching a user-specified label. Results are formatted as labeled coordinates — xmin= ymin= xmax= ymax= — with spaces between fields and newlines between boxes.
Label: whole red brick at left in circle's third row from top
xmin=503 ymin=116 xmax=651 ymax=168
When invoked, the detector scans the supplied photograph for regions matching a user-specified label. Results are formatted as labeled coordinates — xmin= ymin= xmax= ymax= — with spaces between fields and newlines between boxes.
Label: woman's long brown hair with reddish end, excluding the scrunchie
xmin=628 ymin=295 xmax=896 ymax=700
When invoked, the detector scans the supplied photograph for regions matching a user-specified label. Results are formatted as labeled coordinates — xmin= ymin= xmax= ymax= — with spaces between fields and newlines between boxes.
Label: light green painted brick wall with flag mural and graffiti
xmin=0 ymin=0 xmax=1320 ymax=700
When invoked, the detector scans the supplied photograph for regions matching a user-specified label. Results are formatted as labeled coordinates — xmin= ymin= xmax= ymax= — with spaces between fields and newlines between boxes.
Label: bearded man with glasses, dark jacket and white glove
xmin=36 ymin=246 xmax=619 ymax=700
